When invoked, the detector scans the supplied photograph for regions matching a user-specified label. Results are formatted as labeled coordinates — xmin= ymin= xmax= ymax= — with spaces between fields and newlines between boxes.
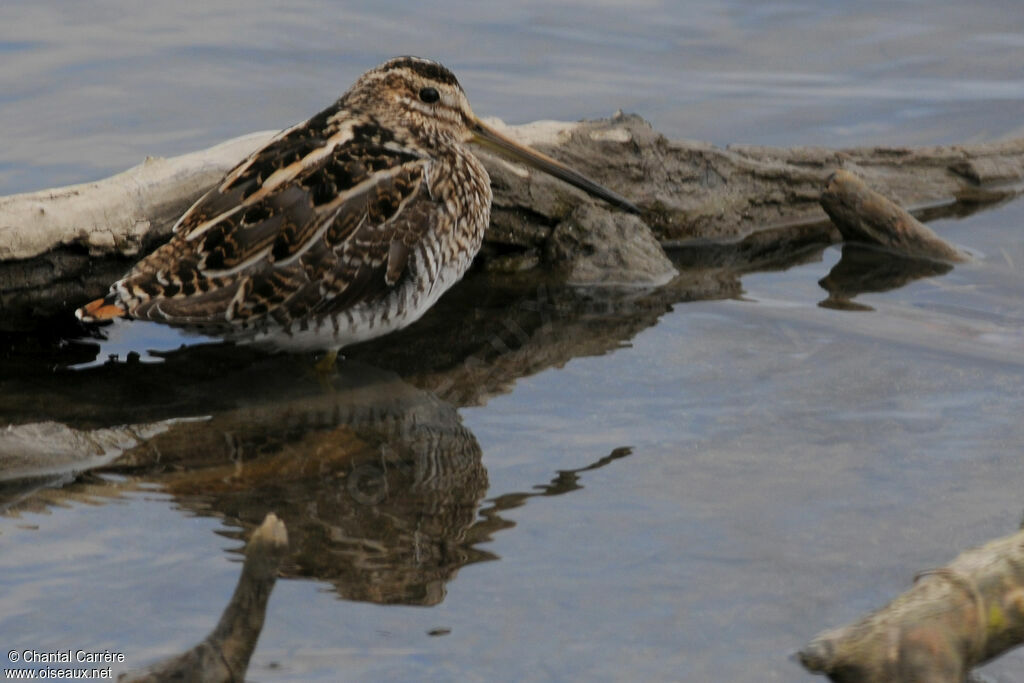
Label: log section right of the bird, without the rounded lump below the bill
xmin=471 ymin=114 xmax=1024 ymax=248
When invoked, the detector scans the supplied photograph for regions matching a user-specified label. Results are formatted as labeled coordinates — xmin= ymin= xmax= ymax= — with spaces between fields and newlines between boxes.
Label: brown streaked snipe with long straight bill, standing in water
xmin=76 ymin=57 xmax=637 ymax=348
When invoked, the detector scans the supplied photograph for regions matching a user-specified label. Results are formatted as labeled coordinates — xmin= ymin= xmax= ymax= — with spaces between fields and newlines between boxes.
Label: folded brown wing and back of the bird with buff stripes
xmin=119 ymin=110 xmax=444 ymax=327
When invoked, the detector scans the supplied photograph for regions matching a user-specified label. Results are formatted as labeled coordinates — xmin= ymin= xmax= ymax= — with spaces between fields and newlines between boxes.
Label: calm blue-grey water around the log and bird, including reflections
xmin=0 ymin=0 xmax=1024 ymax=681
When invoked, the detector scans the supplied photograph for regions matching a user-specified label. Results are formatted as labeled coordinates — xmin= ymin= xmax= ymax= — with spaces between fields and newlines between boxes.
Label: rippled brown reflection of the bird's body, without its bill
xmin=105 ymin=361 xmax=487 ymax=605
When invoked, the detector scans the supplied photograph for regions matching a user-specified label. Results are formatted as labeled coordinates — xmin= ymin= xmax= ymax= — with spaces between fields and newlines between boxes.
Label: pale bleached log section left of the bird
xmin=0 ymin=132 xmax=273 ymax=330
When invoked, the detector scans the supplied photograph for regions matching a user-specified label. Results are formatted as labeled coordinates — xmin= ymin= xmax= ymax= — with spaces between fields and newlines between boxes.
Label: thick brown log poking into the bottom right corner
xmin=798 ymin=530 xmax=1024 ymax=683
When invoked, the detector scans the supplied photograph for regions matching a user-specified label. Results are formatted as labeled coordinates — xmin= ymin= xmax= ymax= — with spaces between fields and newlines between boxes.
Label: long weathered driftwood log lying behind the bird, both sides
xmin=0 ymin=114 xmax=1024 ymax=330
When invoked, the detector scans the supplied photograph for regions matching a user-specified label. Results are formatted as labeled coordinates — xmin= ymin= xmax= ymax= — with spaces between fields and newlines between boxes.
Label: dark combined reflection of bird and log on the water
xmin=0 ymin=235 xmax=819 ymax=577
